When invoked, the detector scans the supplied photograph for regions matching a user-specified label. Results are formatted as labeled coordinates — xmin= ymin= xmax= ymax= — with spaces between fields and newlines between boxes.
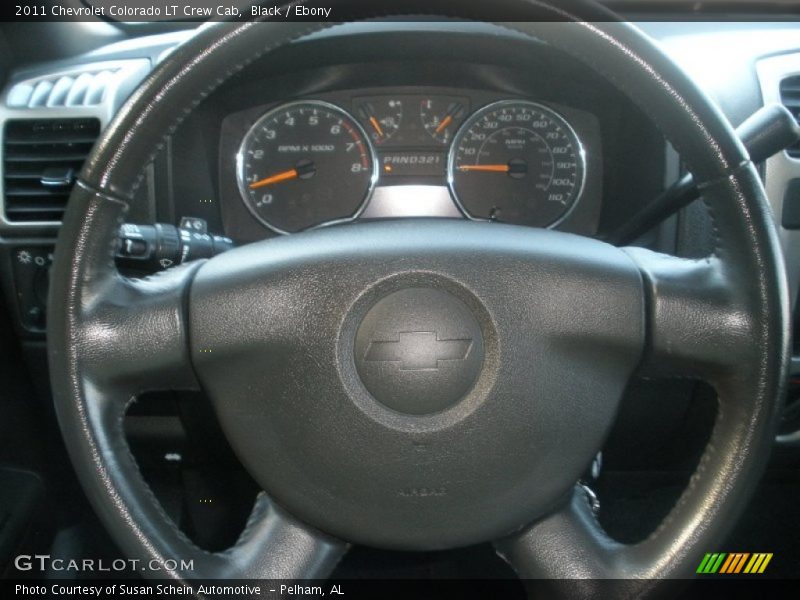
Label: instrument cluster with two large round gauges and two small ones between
xmin=235 ymin=90 xmax=588 ymax=233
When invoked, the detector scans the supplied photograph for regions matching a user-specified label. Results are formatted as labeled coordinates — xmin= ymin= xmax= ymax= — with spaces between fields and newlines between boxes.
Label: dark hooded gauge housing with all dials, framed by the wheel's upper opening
xmin=170 ymin=23 xmax=677 ymax=243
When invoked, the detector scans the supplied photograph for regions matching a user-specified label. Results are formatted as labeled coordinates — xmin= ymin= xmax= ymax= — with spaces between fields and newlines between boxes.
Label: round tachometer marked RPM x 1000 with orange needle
xmin=237 ymin=100 xmax=378 ymax=233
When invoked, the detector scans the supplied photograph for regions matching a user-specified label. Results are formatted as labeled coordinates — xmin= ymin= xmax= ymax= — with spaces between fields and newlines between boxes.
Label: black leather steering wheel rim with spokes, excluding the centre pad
xmin=48 ymin=0 xmax=789 ymax=596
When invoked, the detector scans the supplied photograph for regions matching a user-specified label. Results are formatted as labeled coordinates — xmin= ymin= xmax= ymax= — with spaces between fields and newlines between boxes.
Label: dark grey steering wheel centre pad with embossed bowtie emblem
xmin=188 ymin=219 xmax=645 ymax=550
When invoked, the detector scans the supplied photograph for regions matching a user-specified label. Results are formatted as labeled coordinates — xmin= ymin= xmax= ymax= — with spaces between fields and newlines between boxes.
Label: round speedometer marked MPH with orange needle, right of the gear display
xmin=448 ymin=100 xmax=586 ymax=227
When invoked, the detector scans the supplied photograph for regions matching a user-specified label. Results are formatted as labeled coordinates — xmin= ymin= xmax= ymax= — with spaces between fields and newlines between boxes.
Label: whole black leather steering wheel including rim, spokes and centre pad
xmin=48 ymin=0 xmax=788 ymax=596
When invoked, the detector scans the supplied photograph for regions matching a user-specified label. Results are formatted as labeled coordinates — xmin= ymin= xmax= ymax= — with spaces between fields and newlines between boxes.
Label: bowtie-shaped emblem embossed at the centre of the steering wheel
xmin=364 ymin=331 xmax=472 ymax=371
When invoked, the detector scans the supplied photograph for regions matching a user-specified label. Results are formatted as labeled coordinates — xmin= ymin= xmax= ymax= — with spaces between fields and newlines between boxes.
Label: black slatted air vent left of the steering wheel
xmin=3 ymin=119 xmax=100 ymax=222
